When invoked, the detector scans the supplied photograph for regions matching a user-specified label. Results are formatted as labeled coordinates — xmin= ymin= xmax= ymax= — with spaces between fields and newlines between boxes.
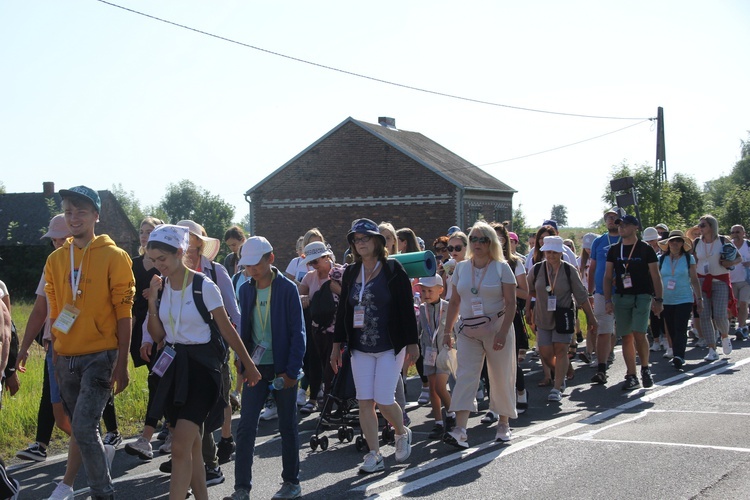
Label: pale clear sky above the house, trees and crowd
xmin=0 ymin=0 xmax=750 ymax=227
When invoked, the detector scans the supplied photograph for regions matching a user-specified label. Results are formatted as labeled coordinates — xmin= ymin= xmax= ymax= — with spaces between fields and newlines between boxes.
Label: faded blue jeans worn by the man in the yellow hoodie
xmin=55 ymin=349 xmax=117 ymax=498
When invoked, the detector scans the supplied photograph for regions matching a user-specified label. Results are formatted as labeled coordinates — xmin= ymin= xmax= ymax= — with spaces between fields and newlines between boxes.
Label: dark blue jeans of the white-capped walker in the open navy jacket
xmin=234 ymin=365 xmax=300 ymax=491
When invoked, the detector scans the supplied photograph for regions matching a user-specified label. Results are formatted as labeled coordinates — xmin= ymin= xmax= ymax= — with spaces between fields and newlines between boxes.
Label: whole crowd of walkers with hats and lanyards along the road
xmin=0 ymin=186 xmax=750 ymax=500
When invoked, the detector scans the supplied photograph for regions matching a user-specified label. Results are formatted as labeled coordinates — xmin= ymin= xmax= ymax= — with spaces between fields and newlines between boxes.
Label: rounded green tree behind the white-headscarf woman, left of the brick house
xmin=157 ymin=179 xmax=234 ymax=239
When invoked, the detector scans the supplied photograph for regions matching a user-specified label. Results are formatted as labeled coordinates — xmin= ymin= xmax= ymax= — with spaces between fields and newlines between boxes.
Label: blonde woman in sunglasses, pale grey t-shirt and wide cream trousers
xmin=443 ymin=221 xmax=517 ymax=449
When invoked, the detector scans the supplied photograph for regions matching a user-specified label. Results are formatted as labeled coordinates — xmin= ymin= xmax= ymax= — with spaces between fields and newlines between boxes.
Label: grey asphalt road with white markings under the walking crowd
xmin=5 ymin=342 xmax=750 ymax=500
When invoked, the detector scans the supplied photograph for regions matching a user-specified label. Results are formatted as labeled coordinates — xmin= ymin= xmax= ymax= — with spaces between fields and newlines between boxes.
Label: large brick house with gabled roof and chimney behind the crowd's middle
xmin=245 ymin=117 xmax=516 ymax=270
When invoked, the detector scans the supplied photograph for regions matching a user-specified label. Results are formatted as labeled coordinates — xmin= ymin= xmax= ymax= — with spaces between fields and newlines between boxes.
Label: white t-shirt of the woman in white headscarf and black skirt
xmin=159 ymin=278 xmax=224 ymax=344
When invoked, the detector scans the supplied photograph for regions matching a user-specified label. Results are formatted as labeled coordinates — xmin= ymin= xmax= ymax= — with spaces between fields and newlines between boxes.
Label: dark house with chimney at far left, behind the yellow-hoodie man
xmin=0 ymin=182 xmax=139 ymax=297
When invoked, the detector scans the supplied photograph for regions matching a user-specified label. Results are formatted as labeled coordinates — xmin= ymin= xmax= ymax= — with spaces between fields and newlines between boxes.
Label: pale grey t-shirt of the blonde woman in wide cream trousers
xmin=453 ymin=260 xmax=521 ymax=318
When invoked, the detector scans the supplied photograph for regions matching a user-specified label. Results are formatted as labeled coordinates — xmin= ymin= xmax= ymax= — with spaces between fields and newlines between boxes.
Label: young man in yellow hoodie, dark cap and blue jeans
xmin=45 ymin=186 xmax=135 ymax=499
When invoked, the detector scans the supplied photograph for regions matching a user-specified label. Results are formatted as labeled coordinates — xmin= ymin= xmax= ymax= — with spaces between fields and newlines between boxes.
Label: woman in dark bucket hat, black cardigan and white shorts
xmin=331 ymin=219 xmax=419 ymax=473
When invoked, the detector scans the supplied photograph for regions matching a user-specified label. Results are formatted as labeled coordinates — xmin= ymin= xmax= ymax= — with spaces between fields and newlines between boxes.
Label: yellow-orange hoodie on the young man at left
xmin=44 ymin=234 xmax=135 ymax=356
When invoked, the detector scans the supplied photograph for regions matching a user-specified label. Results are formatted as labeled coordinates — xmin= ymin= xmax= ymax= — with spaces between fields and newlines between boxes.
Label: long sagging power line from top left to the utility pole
xmin=97 ymin=0 xmax=649 ymax=120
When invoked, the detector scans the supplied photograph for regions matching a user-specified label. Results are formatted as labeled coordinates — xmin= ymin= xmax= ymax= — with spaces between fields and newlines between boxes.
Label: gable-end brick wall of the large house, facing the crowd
xmin=252 ymin=123 xmax=457 ymax=270
